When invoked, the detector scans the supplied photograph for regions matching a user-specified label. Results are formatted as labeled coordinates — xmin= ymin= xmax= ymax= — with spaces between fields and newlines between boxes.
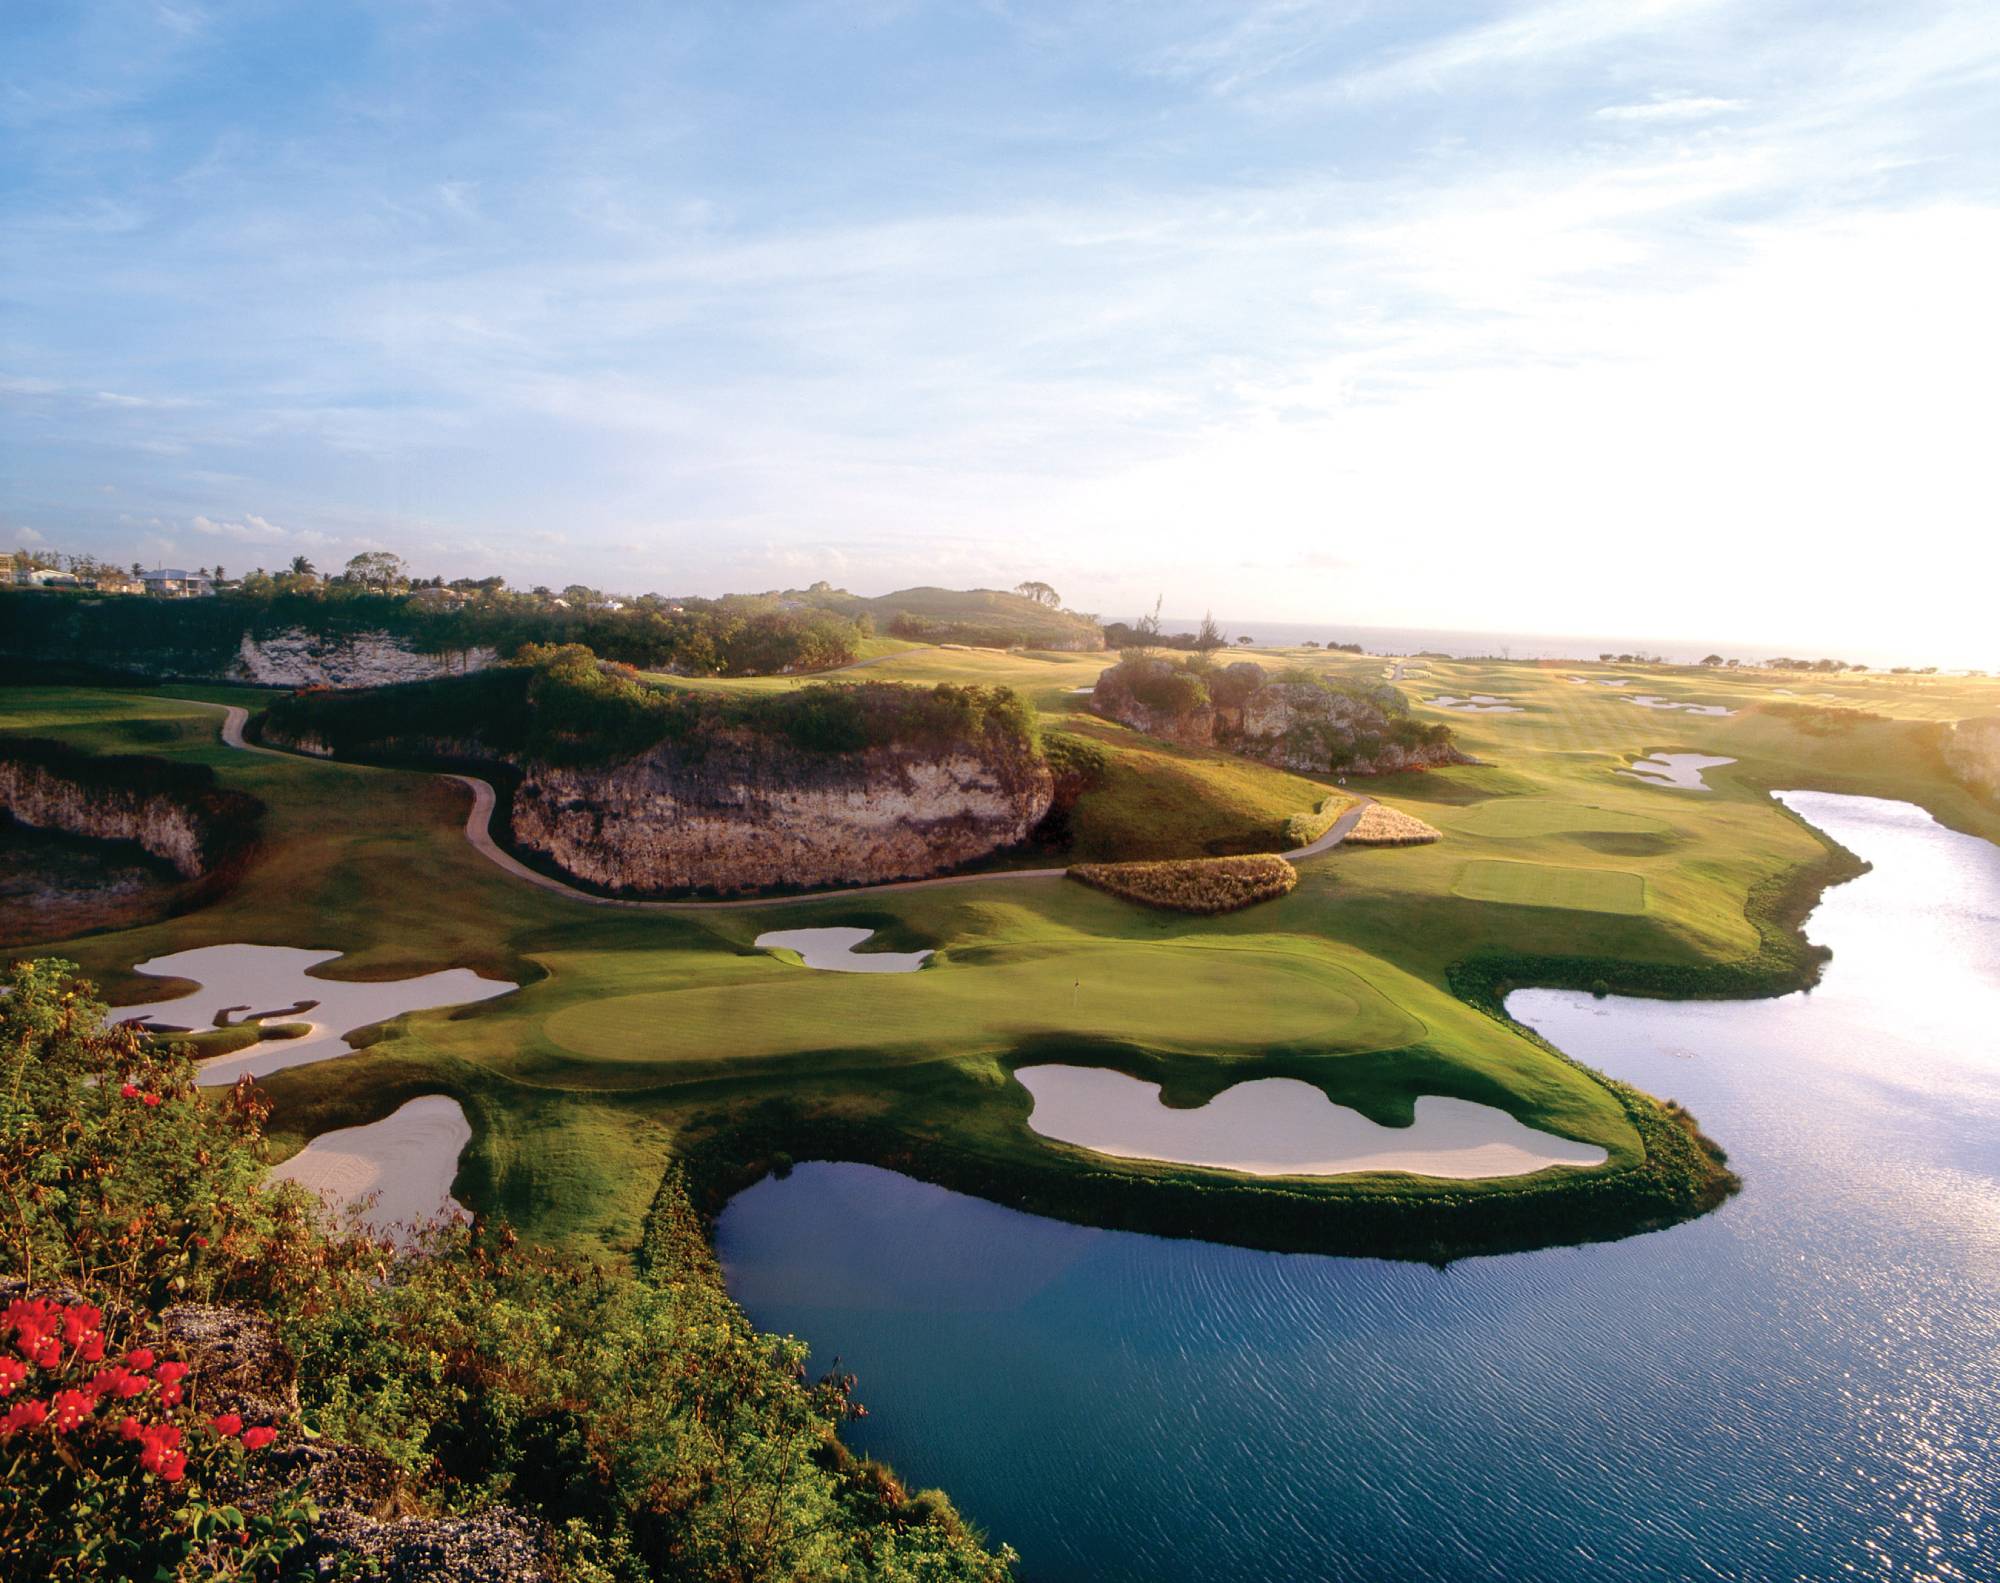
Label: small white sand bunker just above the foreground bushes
xmin=266 ymin=1093 xmax=472 ymax=1241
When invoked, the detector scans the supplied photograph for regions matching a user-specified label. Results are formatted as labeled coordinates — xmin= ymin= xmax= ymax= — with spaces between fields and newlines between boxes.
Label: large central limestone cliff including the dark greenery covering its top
xmin=260 ymin=650 xmax=1054 ymax=893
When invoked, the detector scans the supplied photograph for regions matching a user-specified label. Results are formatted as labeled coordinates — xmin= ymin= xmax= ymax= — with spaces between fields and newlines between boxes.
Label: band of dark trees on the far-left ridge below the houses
xmin=0 ymin=584 xmax=864 ymax=676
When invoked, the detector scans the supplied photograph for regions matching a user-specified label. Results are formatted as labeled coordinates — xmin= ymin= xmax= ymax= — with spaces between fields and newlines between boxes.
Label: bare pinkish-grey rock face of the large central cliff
xmin=514 ymin=732 xmax=1054 ymax=893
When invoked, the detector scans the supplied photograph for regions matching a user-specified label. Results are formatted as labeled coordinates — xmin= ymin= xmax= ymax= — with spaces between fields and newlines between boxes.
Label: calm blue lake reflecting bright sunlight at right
xmin=718 ymin=793 xmax=2000 ymax=1583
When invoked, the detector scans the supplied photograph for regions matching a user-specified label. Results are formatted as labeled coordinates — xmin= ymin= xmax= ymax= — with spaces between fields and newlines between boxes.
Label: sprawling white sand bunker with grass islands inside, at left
xmin=112 ymin=945 xmax=516 ymax=1087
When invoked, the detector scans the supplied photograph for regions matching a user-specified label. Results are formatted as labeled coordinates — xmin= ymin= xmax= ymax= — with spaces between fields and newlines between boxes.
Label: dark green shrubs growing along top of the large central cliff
xmin=264 ymin=644 xmax=1036 ymax=766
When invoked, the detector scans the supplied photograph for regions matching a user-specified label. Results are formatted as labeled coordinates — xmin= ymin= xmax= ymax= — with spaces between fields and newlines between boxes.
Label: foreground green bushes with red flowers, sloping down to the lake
xmin=0 ymin=961 xmax=1010 ymax=1583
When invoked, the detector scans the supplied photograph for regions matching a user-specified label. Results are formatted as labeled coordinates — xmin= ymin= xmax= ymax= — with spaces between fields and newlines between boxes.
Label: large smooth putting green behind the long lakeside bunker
xmin=542 ymin=939 xmax=1424 ymax=1079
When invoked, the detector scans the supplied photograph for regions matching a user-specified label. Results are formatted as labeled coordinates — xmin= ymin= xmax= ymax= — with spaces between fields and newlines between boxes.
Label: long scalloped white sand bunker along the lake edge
xmin=1014 ymin=1065 xmax=1604 ymax=1177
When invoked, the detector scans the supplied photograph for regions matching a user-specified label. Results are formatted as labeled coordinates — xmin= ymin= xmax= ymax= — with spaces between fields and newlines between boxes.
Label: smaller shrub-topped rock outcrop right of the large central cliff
xmin=1090 ymin=656 xmax=1468 ymax=776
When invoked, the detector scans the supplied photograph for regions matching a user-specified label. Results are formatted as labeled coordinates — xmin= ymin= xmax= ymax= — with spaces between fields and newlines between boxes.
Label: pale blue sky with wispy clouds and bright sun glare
xmin=0 ymin=0 xmax=2000 ymax=668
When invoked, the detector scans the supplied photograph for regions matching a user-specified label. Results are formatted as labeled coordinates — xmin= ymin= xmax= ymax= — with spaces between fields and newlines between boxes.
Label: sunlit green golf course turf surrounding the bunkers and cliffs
xmin=0 ymin=650 xmax=2000 ymax=1245
